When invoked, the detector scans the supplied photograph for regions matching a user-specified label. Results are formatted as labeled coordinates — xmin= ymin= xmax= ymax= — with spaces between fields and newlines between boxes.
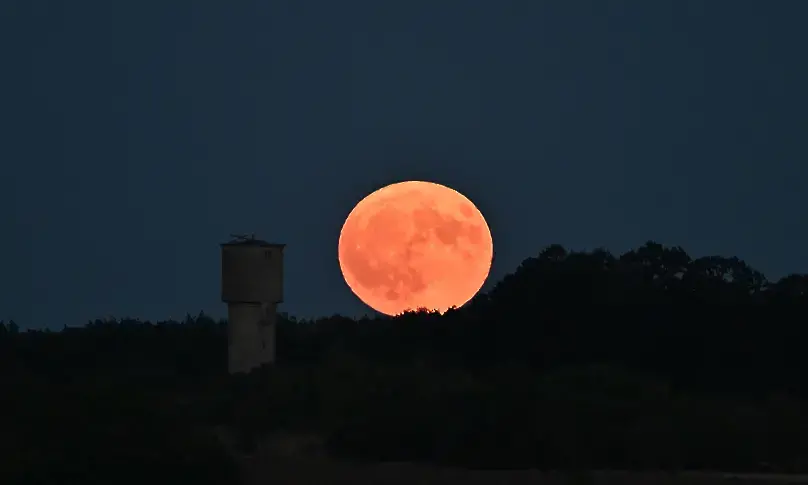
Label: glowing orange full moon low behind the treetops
xmin=339 ymin=181 xmax=494 ymax=315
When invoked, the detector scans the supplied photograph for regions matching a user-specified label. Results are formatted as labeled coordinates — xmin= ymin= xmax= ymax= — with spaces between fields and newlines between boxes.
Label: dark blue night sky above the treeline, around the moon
xmin=0 ymin=0 xmax=808 ymax=327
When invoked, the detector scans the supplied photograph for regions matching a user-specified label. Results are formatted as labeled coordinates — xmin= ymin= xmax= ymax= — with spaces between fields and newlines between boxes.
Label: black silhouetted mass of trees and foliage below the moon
xmin=0 ymin=242 xmax=808 ymax=484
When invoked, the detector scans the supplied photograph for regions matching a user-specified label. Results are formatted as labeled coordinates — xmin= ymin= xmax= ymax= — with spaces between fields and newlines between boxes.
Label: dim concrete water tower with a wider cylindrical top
xmin=222 ymin=235 xmax=285 ymax=374
